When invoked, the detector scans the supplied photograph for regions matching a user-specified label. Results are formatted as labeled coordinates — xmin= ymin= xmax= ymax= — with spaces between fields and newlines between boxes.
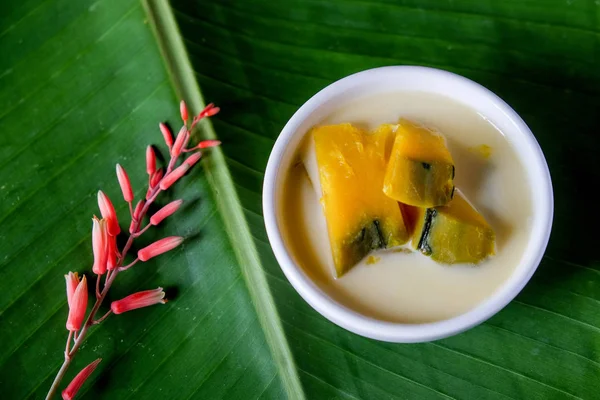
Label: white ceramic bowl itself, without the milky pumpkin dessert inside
xmin=263 ymin=66 xmax=554 ymax=343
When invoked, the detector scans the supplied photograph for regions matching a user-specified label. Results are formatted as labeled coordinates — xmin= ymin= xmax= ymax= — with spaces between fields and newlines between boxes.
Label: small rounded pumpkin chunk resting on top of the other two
xmin=383 ymin=119 xmax=454 ymax=207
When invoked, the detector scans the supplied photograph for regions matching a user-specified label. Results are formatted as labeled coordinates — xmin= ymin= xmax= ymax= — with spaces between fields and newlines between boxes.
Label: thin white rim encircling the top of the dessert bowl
xmin=262 ymin=66 xmax=554 ymax=343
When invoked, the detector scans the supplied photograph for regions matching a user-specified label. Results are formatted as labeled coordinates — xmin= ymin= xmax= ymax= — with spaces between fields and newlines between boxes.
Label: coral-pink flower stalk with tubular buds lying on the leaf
xmin=46 ymin=101 xmax=220 ymax=400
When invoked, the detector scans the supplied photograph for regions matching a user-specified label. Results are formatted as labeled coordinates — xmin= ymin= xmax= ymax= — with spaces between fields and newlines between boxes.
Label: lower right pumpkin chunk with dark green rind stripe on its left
xmin=412 ymin=191 xmax=495 ymax=264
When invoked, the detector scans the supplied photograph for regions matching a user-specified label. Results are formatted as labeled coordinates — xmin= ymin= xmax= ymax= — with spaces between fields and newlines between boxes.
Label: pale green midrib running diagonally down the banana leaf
xmin=143 ymin=0 xmax=305 ymax=399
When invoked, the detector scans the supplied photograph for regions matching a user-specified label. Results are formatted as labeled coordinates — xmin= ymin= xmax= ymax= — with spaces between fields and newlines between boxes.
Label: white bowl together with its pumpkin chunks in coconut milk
xmin=263 ymin=66 xmax=553 ymax=342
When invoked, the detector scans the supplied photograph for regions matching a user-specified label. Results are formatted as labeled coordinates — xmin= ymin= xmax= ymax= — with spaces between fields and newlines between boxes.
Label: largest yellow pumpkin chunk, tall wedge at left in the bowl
xmin=312 ymin=124 xmax=408 ymax=277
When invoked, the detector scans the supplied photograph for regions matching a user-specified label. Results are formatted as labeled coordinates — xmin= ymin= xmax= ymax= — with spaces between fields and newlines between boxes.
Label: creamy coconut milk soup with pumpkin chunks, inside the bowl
xmin=277 ymin=92 xmax=532 ymax=323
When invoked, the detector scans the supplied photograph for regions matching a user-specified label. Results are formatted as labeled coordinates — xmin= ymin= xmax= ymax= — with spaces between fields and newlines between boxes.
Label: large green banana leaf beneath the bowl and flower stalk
xmin=0 ymin=0 xmax=600 ymax=399
